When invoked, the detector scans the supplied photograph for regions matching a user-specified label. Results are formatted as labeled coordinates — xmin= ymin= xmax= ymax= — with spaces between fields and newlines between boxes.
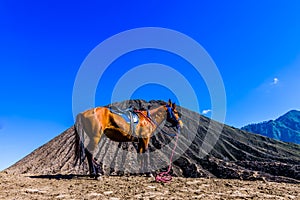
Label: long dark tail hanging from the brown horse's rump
xmin=74 ymin=116 xmax=86 ymax=166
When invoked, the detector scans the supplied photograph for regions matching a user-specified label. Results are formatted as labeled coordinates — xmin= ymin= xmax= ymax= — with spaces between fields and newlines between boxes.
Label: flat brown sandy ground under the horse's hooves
xmin=0 ymin=172 xmax=300 ymax=200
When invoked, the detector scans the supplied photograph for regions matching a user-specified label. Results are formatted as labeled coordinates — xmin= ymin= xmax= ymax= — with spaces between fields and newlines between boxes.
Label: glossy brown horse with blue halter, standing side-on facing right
xmin=75 ymin=100 xmax=183 ymax=178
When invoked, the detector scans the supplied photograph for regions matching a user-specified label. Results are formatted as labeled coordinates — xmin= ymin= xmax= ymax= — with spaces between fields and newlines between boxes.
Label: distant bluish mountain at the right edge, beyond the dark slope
xmin=241 ymin=110 xmax=300 ymax=144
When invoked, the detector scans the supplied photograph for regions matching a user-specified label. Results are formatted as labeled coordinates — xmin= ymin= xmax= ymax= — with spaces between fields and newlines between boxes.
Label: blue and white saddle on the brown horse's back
xmin=109 ymin=106 xmax=139 ymax=136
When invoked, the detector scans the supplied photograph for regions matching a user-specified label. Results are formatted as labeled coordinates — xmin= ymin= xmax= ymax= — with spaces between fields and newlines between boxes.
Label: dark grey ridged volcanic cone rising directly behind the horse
xmin=5 ymin=100 xmax=300 ymax=183
